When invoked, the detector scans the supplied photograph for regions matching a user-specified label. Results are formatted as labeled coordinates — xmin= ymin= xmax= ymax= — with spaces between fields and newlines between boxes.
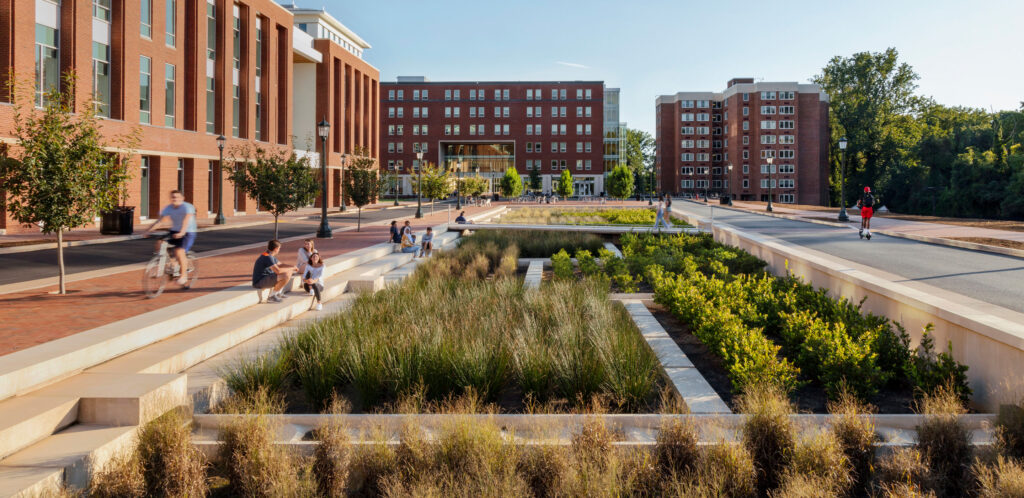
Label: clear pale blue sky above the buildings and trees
xmin=299 ymin=0 xmax=1024 ymax=132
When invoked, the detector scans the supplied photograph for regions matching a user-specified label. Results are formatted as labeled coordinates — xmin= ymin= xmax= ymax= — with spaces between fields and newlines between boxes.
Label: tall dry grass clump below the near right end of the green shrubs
xmin=918 ymin=387 xmax=974 ymax=496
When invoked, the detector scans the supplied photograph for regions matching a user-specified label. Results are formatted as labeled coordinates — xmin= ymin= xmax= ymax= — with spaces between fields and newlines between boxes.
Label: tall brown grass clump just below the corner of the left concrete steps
xmin=136 ymin=411 xmax=209 ymax=497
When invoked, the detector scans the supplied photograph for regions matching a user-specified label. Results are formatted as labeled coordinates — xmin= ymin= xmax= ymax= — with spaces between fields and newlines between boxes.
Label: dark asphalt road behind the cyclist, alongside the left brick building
xmin=0 ymin=203 xmax=432 ymax=285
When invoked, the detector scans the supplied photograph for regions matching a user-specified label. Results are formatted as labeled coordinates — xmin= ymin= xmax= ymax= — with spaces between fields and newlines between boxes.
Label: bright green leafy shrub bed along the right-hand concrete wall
xmin=622 ymin=234 xmax=971 ymax=400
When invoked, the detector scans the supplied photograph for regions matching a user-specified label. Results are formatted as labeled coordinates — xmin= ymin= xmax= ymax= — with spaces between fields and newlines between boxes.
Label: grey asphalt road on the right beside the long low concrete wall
xmin=672 ymin=201 xmax=1024 ymax=313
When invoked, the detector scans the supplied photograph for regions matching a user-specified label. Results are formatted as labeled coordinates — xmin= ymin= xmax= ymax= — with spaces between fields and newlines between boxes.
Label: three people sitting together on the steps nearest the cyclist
xmin=253 ymin=239 xmax=324 ymax=310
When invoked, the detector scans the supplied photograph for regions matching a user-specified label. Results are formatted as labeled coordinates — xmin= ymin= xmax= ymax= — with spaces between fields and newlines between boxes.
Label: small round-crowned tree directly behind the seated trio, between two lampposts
xmin=228 ymin=146 xmax=321 ymax=239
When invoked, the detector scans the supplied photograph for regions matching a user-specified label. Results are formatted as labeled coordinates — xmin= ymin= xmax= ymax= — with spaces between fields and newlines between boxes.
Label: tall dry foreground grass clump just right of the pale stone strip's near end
xmin=737 ymin=385 xmax=796 ymax=494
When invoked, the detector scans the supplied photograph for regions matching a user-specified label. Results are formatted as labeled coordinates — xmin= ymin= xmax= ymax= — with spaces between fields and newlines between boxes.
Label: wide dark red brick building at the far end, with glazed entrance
xmin=380 ymin=77 xmax=620 ymax=196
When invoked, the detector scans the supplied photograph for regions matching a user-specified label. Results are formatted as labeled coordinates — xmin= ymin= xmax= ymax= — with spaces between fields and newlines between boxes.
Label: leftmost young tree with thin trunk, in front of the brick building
xmin=0 ymin=73 xmax=137 ymax=294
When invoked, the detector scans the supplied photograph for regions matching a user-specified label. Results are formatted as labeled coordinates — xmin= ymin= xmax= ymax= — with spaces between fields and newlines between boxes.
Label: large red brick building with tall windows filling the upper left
xmin=0 ymin=0 xmax=379 ymax=233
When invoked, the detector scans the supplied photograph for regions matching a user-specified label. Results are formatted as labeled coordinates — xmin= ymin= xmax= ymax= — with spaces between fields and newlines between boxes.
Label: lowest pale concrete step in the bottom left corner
xmin=0 ymin=424 xmax=138 ymax=496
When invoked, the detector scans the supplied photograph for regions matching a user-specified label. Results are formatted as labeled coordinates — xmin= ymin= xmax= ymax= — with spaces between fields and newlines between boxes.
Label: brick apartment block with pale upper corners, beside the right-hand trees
xmin=655 ymin=78 xmax=829 ymax=204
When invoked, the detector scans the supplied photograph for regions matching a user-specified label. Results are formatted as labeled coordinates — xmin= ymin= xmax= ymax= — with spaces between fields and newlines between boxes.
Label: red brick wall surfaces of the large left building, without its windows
xmin=0 ymin=0 xmax=379 ymax=233
